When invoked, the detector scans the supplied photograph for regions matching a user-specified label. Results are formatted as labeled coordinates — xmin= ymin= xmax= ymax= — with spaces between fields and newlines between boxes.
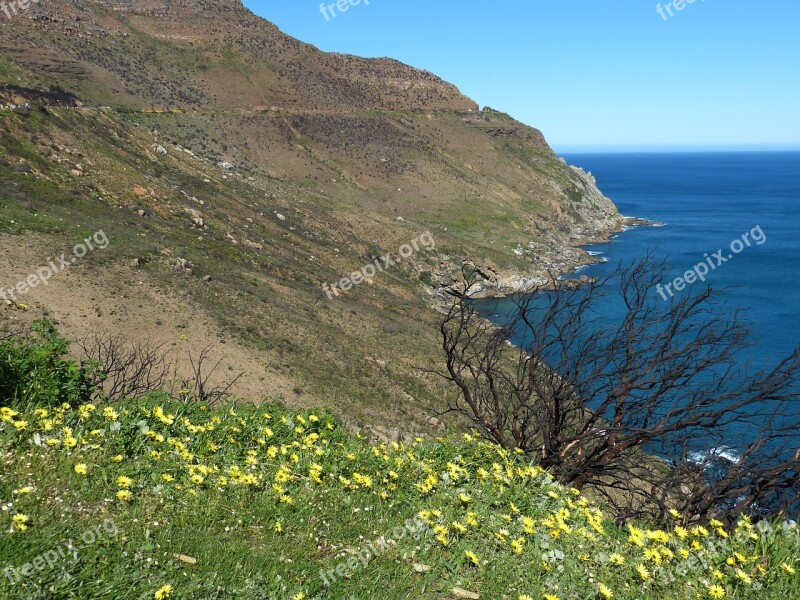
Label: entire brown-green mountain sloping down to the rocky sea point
xmin=0 ymin=0 xmax=620 ymax=436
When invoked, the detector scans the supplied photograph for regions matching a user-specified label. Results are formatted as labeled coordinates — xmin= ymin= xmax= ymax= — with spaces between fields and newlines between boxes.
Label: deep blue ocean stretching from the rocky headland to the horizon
xmin=479 ymin=152 xmax=800 ymax=458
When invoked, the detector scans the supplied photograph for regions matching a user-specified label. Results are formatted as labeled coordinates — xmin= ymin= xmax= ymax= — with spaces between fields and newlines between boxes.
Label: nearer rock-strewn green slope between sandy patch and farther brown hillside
xmin=0 ymin=104 xmax=456 ymax=429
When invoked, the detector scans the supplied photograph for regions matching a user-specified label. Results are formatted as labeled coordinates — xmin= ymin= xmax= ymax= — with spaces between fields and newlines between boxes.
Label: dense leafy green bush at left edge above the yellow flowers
xmin=0 ymin=320 xmax=95 ymax=407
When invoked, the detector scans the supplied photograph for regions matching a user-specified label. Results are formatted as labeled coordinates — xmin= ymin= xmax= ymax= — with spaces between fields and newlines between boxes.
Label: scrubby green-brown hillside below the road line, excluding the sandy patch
xmin=0 ymin=57 xmax=612 ymax=431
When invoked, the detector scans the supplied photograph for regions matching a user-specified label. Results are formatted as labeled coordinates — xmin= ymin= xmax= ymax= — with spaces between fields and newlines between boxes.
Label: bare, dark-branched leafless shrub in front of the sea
xmin=437 ymin=256 xmax=800 ymax=520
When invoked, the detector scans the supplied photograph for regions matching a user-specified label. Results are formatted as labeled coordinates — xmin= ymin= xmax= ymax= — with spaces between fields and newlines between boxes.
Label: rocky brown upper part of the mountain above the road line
xmin=5 ymin=0 xmax=478 ymax=111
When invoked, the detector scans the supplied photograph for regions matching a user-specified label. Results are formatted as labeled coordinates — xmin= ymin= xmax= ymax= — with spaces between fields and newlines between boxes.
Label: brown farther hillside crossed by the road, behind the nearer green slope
xmin=0 ymin=0 xmax=620 ymax=272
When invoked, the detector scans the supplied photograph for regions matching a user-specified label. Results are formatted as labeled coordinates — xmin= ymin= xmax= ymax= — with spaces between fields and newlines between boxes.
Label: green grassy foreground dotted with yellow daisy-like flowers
xmin=0 ymin=397 xmax=800 ymax=600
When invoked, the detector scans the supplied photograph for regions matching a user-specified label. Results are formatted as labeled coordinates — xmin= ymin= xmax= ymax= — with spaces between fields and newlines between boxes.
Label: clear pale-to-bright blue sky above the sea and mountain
xmin=244 ymin=0 xmax=800 ymax=152
